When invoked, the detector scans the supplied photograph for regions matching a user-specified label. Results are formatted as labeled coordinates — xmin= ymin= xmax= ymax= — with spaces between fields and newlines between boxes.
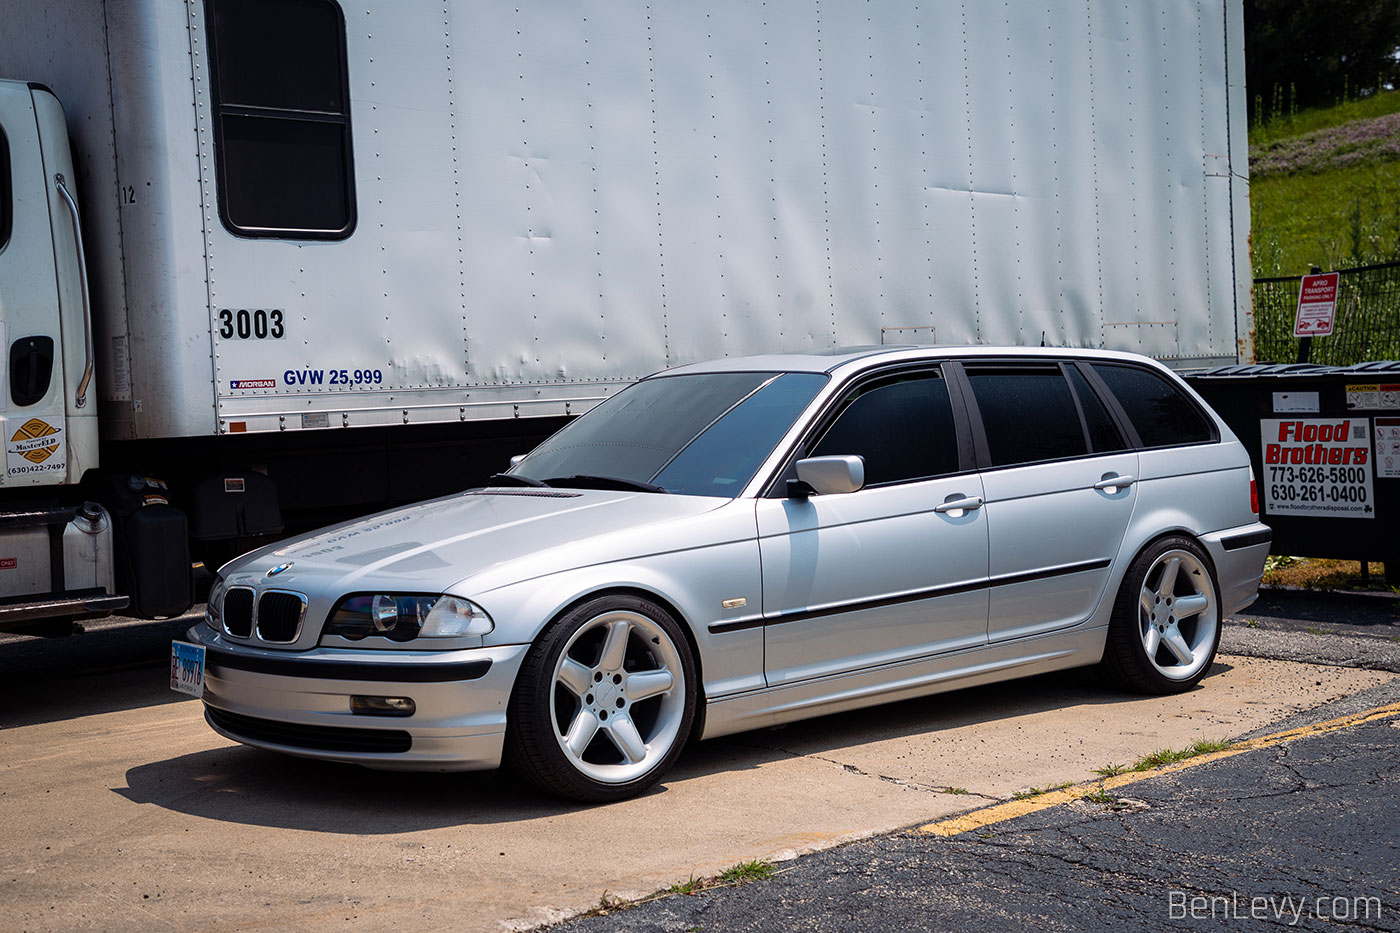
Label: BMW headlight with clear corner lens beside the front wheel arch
xmin=322 ymin=593 xmax=496 ymax=642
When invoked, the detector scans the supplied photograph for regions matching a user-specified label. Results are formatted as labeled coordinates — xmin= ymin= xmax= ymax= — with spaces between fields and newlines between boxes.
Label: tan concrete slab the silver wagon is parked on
xmin=0 ymin=657 xmax=1394 ymax=932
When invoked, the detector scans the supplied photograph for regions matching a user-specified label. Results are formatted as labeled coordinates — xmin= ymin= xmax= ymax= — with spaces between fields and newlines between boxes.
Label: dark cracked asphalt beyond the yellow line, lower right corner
xmin=550 ymin=672 xmax=1400 ymax=933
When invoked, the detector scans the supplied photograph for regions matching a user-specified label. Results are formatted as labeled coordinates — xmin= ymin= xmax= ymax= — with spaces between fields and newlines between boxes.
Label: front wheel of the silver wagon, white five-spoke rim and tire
xmin=505 ymin=594 xmax=697 ymax=803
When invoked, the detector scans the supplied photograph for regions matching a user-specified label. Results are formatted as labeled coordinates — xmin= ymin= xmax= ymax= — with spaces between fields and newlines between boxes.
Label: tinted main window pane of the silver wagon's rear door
xmin=967 ymin=366 xmax=1088 ymax=467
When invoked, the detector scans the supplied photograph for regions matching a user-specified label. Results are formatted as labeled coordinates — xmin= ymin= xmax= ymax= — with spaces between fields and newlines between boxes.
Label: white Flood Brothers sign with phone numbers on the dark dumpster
xmin=1259 ymin=417 xmax=1376 ymax=518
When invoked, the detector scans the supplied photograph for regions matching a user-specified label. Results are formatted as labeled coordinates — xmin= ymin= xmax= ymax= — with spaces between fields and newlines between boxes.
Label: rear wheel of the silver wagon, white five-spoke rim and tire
xmin=1099 ymin=535 xmax=1221 ymax=693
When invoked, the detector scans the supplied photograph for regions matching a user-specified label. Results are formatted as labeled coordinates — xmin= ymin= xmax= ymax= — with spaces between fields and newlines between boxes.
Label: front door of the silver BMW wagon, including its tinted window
xmin=757 ymin=367 xmax=987 ymax=685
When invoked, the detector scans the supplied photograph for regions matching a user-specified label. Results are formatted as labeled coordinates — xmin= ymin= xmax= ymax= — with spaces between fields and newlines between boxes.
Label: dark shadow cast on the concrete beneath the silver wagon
xmin=113 ymin=663 xmax=1231 ymax=835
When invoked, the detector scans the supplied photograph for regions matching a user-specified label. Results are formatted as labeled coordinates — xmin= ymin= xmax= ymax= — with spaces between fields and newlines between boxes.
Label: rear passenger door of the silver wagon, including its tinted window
xmin=963 ymin=360 xmax=1138 ymax=642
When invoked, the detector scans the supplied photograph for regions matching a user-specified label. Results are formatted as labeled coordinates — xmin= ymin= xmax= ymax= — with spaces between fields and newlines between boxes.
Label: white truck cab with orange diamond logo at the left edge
xmin=0 ymin=81 xmax=129 ymax=632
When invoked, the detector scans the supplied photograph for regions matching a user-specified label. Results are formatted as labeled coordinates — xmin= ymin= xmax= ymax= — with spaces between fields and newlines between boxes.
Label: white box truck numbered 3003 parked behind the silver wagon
xmin=0 ymin=0 xmax=1252 ymax=629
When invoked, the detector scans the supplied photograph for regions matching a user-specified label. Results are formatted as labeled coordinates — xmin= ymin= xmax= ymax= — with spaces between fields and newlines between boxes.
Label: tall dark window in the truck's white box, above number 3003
xmin=204 ymin=0 xmax=356 ymax=240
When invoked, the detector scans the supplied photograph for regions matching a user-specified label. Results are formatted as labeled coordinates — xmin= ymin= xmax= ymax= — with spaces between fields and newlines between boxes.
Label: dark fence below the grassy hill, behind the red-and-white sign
xmin=1254 ymin=262 xmax=1400 ymax=366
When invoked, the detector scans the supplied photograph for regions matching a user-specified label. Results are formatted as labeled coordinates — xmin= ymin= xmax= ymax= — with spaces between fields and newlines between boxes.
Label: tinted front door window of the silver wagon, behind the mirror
xmin=808 ymin=373 xmax=958 ymax=486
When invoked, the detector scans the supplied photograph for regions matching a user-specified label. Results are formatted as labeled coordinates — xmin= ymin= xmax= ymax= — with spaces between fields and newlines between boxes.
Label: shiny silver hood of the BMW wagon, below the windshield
xmin=220 ymin=489 xmax=729 ymax=595
